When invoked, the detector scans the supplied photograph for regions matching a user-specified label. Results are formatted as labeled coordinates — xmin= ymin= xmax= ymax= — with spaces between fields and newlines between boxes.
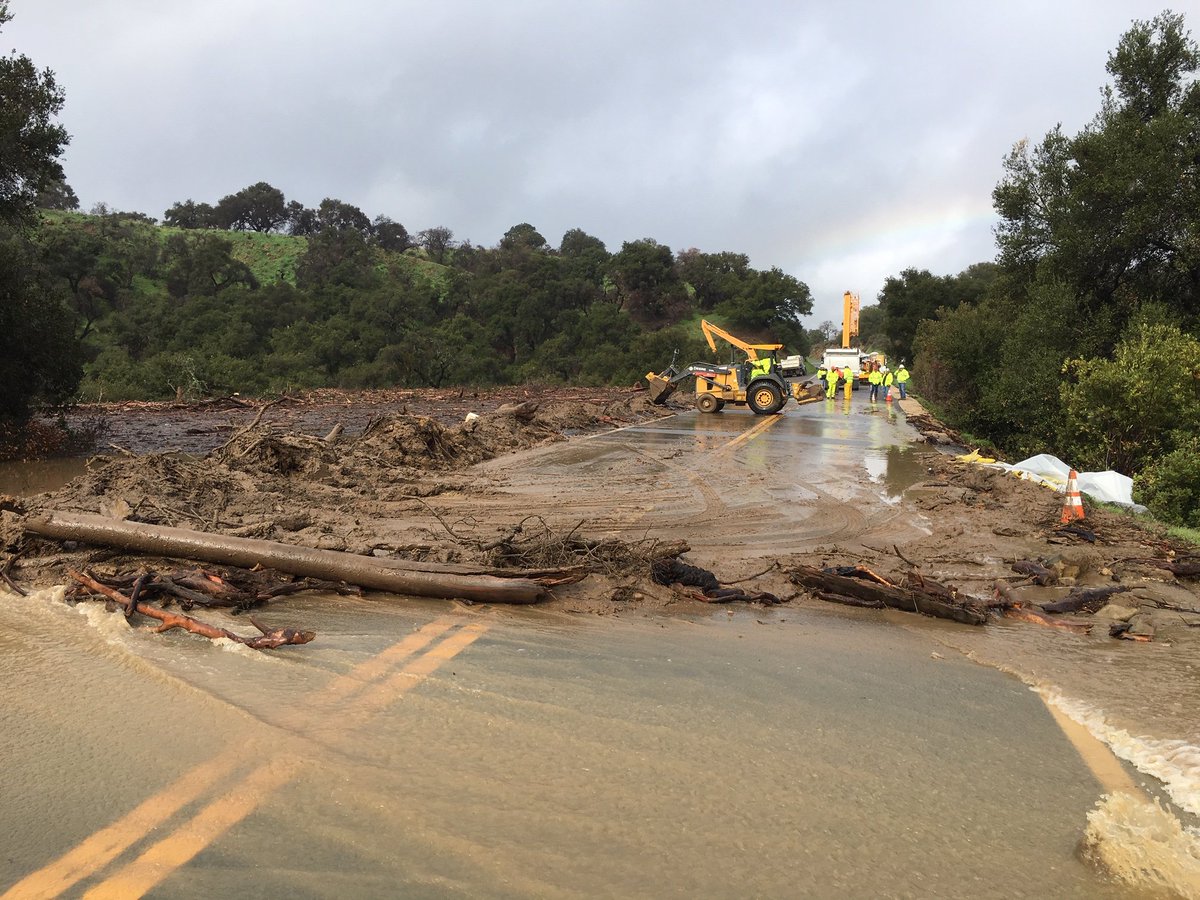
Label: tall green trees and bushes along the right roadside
xmin=880 ymin=13 xmax=1200 ymax=526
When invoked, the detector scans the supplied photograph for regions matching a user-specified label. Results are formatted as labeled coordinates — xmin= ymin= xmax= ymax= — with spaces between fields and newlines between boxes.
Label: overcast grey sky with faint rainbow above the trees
xmin=0 ymin=0 xmax=1180 ymax=326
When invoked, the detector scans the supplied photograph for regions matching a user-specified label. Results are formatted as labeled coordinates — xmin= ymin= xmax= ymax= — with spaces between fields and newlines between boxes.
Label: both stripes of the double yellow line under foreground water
xmin=0 ymin=616 xmax=487 ymax=900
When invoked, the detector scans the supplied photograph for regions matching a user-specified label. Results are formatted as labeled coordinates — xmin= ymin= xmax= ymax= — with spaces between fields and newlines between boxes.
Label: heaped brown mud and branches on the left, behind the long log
xmin=7 ymin=391 xmax=710 ymax=633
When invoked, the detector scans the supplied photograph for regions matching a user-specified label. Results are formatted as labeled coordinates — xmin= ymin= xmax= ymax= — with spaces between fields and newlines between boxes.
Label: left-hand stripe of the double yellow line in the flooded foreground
xmin=0 ymin=616 xmax=461 ymax=900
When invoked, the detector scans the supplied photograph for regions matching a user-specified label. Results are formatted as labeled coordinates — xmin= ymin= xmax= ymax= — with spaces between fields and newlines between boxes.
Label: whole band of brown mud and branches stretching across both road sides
xmin=0 ymin=388 xmax=1200 ymax=641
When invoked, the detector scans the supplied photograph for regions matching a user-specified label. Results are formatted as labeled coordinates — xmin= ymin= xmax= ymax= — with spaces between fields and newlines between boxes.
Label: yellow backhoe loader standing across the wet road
xmin=646 ymin=319 xmax=821 ymax=415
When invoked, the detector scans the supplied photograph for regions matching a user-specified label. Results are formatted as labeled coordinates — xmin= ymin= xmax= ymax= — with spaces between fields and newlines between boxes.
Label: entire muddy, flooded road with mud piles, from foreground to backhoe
xmin=0 ymin=395 xmax=1200 ymax=896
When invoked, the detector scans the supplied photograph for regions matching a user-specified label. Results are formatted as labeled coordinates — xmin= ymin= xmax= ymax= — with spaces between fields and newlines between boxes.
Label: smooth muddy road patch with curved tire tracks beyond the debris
xmin=403 ymin=415 xmax=913 ymax=558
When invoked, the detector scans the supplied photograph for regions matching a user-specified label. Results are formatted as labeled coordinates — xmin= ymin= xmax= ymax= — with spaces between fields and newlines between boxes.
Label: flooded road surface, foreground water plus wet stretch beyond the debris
xmin=0 ymin=402 xmax=1189 ymax=898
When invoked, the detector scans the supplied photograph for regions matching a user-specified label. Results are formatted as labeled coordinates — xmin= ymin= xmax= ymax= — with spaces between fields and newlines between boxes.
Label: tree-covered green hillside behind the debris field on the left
xmin=18 ymin=210 xmax=811 ymax=400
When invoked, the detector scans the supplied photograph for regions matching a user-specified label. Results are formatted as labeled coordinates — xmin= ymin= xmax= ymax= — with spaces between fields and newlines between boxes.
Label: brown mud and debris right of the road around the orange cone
xmin=792 ymin=442 xmax=1200 ymax=643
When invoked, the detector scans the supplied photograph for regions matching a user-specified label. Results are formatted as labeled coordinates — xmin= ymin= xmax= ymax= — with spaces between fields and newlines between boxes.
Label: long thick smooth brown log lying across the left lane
xmin=24 ymin=511 xmax=547 ymax=604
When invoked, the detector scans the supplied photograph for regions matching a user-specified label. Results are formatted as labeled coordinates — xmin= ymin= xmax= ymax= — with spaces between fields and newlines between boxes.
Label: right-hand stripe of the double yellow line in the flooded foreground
xmin=84 ymin=623 xmax=487 ymax=900
